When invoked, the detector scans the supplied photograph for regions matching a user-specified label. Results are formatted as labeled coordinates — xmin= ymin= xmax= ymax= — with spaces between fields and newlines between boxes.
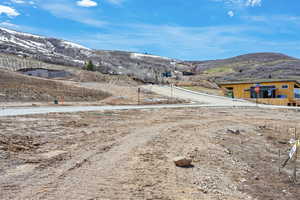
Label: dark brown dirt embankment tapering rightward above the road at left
xmin=0 ymin=70 xmax=110 ymax=102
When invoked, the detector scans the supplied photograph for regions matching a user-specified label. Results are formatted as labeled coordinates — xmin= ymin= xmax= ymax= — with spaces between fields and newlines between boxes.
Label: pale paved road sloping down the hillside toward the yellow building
xmin=143 ymin=85 xmax=255 ymax=106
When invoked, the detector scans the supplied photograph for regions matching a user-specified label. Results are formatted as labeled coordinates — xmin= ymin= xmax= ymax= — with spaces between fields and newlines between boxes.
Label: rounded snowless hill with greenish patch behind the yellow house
xmin=188 ymin=53 xmax=300 ymax=81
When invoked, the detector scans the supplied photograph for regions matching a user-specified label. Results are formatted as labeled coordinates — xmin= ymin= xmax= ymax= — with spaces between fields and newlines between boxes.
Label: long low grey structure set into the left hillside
xmin=18 ymin=68 xmax=71 ymax=78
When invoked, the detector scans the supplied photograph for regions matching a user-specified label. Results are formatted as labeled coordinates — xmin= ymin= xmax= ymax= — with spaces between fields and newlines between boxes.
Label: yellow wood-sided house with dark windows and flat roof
xmin=218 ymin=80 xmax=300 ymax=106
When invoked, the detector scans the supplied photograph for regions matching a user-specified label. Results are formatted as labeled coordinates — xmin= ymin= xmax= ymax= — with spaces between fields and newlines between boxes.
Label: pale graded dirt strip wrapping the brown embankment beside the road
xmin=0 ymin=85 xmax=183 ymax=108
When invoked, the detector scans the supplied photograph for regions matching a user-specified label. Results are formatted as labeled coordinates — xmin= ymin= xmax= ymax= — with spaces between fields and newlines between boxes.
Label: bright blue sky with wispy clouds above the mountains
xmin=0 ymin=0 xmax=300 ymax=60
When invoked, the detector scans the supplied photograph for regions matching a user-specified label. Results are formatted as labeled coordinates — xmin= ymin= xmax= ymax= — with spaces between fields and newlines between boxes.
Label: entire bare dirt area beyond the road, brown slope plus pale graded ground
xmin=0 ymin=69 xmax=186 ymax=107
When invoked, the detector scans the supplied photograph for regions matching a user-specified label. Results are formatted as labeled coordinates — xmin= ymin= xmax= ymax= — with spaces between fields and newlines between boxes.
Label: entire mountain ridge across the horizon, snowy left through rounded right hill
xmin=0 ymin=27 xmax=300 ymax=82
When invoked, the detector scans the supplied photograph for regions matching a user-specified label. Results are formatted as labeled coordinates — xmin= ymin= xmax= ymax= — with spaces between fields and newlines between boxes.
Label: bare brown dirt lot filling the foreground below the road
xmin=0 ymin=108 xmax=300 ymax=200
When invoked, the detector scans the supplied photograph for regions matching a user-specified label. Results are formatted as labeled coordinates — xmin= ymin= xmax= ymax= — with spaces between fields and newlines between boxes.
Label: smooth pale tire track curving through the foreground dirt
xmin=31 ymin=122 xmax=184 ymax=199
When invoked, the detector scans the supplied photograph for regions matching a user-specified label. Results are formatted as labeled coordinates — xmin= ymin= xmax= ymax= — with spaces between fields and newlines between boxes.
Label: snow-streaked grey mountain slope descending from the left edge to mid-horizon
xmin=0 ymin=27 xmax=188 ymax=81
